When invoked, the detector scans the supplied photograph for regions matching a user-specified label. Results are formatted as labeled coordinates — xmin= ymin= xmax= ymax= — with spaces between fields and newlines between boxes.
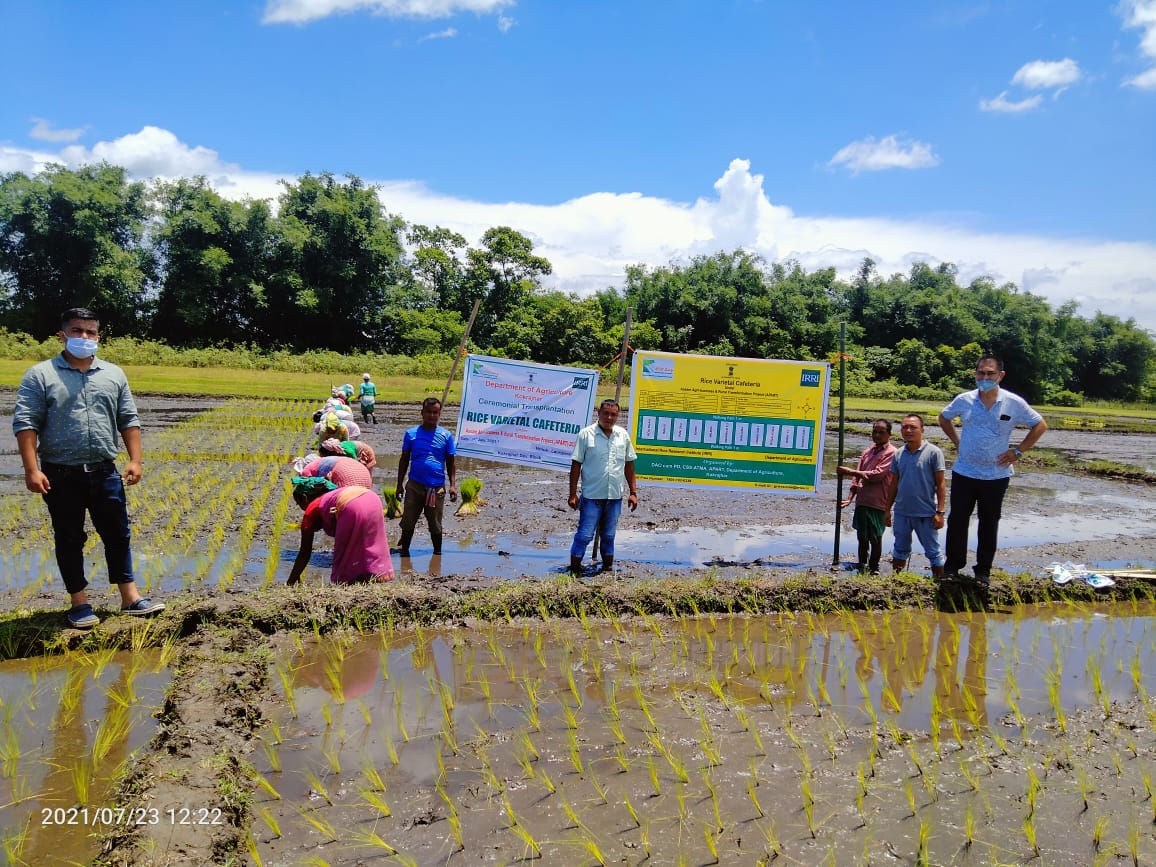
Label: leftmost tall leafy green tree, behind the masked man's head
xmin=0 ymin=163 xmax=155 ymax=336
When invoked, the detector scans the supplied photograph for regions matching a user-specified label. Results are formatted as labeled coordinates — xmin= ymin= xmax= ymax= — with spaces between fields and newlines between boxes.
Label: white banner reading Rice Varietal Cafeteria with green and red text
xmin=457 ymin=355 xmax=598 ymax=470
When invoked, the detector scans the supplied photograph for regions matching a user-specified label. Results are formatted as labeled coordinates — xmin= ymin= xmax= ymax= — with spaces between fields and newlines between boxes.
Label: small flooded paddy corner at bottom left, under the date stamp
xmin=0 ymin=651 xmax=170 ymax=865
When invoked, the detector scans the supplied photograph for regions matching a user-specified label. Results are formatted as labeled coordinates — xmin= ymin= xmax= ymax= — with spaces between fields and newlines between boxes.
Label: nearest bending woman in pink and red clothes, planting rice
xmin=287 ymin=476 xmax=393 ymax=585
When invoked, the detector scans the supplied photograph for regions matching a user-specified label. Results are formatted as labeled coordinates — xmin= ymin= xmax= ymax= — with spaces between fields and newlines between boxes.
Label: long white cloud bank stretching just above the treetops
xmin=9 ymin=127 xmax=1156 ymax=331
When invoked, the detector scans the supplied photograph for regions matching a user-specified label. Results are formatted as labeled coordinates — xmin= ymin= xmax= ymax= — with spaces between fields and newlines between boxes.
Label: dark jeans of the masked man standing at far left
xmin=40 ymin=460 xmax=133 ymax=593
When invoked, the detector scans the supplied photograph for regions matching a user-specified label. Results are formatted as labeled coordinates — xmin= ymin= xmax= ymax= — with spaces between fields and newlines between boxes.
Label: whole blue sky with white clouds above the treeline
xmin=0 ymin=0 xmax=1156 ymax=329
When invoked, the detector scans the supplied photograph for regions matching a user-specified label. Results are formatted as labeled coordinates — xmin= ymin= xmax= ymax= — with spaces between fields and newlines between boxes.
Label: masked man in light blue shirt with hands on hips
xmin=939 ymin=355 xmax=1047 ymax=584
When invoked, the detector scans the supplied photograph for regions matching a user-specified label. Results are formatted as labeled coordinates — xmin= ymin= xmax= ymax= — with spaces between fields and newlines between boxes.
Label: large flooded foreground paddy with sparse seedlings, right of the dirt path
xmin=253 ymin=606 xmax=1156 ymax=865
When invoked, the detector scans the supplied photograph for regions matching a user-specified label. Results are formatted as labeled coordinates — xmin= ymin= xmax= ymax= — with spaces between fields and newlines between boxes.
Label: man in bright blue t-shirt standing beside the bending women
xmin=398 ymin=398 xmax=458 ymax=557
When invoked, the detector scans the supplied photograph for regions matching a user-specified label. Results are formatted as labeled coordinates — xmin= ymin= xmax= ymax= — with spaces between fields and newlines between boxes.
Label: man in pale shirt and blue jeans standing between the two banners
xmin=566 ymin=400 xmax=638 ymax=575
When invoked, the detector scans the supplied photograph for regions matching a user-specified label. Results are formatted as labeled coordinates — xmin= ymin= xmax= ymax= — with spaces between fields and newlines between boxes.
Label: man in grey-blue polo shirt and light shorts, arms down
xmin=884 ymin=414 xmax=947 ymax=578
